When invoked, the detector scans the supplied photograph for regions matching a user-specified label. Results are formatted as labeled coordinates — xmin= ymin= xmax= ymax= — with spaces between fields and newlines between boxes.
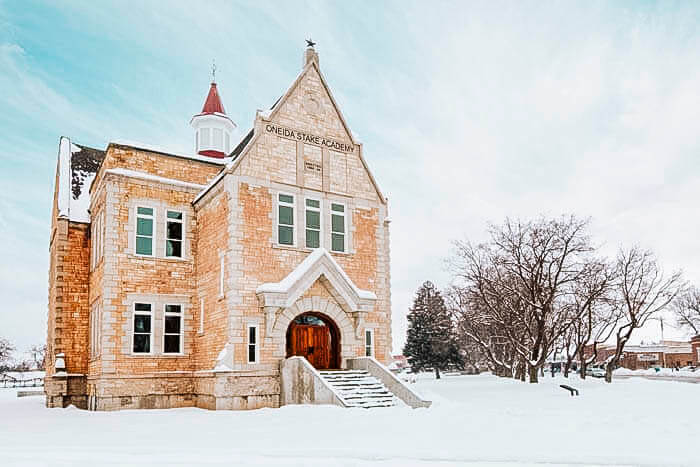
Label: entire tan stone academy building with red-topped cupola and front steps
xmin=45 ymin=47 xmax=427 ymax=410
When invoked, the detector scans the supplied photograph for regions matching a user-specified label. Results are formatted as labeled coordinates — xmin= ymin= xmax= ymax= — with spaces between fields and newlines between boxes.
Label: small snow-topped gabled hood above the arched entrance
xmin=256 ymin=248 xmax=377 ymax=311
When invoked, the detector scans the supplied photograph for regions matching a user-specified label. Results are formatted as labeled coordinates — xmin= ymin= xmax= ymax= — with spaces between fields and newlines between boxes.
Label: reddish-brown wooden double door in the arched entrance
xmin=287 ymin=312 xmax=340 ymax=370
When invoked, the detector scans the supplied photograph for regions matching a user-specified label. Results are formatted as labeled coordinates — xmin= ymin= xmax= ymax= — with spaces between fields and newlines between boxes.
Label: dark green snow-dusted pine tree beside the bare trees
xmin=403 ymin=281 xmax=462 ymax=379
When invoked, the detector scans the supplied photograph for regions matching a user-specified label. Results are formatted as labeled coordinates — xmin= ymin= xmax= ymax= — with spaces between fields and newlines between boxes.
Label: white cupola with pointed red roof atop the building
xmin=190 ymin=72 xmax=236 ymax=158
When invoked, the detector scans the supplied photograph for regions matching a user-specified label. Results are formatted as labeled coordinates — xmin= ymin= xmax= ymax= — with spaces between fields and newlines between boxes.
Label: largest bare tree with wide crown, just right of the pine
xmin=448 ymin=216 xmax=594 ymax=383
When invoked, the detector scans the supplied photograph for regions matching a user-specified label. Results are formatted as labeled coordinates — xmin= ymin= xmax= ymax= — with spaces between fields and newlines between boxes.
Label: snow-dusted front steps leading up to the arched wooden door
xmin=319 ymin=370 xmax=396 ymax=408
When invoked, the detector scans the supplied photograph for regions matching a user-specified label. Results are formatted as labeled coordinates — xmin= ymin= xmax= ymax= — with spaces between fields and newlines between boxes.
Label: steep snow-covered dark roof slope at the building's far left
xmin=57 ymin=136 xmax=105 ymax=223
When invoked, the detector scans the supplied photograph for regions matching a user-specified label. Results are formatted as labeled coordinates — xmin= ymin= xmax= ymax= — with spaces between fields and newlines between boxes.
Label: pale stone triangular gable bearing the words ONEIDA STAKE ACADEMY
xmin=224 ymin=52 xmax=386 ymax=202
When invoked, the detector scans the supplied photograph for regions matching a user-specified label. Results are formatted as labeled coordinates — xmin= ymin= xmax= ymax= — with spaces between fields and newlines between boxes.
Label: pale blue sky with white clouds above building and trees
xmin=0 ymin=0 xmax=700 ymax=352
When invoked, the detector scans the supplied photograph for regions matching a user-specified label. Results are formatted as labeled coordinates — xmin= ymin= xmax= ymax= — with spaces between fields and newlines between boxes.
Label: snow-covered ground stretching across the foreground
xmin=0 ymin=375 xmax=700 ymax=467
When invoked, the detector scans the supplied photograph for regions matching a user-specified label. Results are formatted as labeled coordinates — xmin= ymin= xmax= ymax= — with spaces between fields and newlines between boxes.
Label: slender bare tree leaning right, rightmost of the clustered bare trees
xmin=605 ymin=247 xmax=684 ymax=383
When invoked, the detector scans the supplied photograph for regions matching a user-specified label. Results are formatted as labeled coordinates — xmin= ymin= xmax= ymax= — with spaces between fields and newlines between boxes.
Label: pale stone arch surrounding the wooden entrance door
xmin=270 ymin=296 xmax=357 ymax=367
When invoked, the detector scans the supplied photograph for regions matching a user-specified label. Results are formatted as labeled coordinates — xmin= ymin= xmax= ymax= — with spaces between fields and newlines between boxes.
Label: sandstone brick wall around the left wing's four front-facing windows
xmin=102 ymin=175 xmax=198 ymax=375
